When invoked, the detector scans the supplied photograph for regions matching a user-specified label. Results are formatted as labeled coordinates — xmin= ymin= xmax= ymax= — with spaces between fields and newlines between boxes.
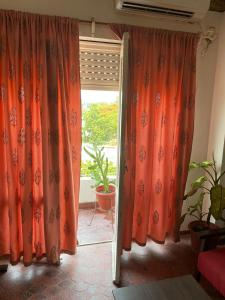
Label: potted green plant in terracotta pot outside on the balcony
xmin=84 ymin=146 xmax=116 ymax=210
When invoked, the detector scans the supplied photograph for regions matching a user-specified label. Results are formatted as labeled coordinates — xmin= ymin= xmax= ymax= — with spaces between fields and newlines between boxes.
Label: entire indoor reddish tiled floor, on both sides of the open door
xmin=0 ymin=236 xmax=224 ymax=300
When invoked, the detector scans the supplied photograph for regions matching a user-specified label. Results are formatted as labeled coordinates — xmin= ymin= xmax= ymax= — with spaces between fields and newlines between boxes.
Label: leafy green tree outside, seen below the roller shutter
xmin=82 ymin=103 xmax=118 ymax=146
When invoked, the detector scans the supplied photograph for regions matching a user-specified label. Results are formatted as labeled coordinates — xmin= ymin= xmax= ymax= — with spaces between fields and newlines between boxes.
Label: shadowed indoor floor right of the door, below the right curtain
xmin=121 ymin=235 xmax=224 ymax=300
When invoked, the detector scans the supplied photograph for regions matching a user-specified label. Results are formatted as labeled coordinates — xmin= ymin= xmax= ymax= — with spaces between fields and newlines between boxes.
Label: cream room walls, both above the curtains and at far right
xmin=0 ymin=0 xmax=221 ymax=229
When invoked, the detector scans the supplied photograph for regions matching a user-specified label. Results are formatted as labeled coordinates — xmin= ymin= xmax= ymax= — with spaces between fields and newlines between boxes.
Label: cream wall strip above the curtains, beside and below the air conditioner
xmin=0 ymin=0 xmax=214 ymax=31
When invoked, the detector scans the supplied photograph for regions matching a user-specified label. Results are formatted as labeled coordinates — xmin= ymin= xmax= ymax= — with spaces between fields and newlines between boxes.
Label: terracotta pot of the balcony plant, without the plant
xmin=96 ymin=184 xmax=116 ymax=210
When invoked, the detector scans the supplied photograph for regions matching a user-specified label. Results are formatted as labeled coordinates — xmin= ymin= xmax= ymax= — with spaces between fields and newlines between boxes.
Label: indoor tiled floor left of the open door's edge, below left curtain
xmin=0 ymin=244 xmax=113 ymax=300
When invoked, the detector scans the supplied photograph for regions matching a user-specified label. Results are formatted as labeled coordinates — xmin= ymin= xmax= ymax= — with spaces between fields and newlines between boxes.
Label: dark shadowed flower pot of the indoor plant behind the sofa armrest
xmin=188 ymin=221 xmax=218 ymax=252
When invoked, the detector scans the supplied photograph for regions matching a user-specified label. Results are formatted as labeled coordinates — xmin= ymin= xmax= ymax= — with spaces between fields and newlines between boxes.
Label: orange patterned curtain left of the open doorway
xmin=0 ymin=11 xmax=81 ymax=265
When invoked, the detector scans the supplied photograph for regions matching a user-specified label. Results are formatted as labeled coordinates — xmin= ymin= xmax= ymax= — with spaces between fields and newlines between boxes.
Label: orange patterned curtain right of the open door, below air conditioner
xmin=110 ymin=24 xmax=198 ymax=250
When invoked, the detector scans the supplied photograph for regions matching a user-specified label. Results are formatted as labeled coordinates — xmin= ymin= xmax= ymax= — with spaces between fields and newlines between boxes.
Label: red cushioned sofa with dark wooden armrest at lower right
xmin=198 ymin=228 xmax=225 ymax=297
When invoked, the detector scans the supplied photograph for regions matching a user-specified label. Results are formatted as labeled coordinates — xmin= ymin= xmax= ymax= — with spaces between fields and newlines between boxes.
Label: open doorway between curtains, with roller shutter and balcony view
xmin=78 ymin=39 xmax=121 ymax=245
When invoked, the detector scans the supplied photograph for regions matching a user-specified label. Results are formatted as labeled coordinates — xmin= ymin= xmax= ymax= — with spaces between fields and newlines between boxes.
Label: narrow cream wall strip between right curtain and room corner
xmin=181 ymin=14 xmax=222 ymax=230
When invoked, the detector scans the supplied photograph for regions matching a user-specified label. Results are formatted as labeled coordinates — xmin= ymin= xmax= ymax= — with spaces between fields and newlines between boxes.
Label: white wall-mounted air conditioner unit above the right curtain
xmin=115 ymin=0 xmax=210 ymax=22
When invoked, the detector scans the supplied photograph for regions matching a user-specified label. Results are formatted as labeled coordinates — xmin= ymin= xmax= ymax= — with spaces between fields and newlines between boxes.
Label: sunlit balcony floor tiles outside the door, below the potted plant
xmin=78 ymin=209 xmax=113 ymax=245
